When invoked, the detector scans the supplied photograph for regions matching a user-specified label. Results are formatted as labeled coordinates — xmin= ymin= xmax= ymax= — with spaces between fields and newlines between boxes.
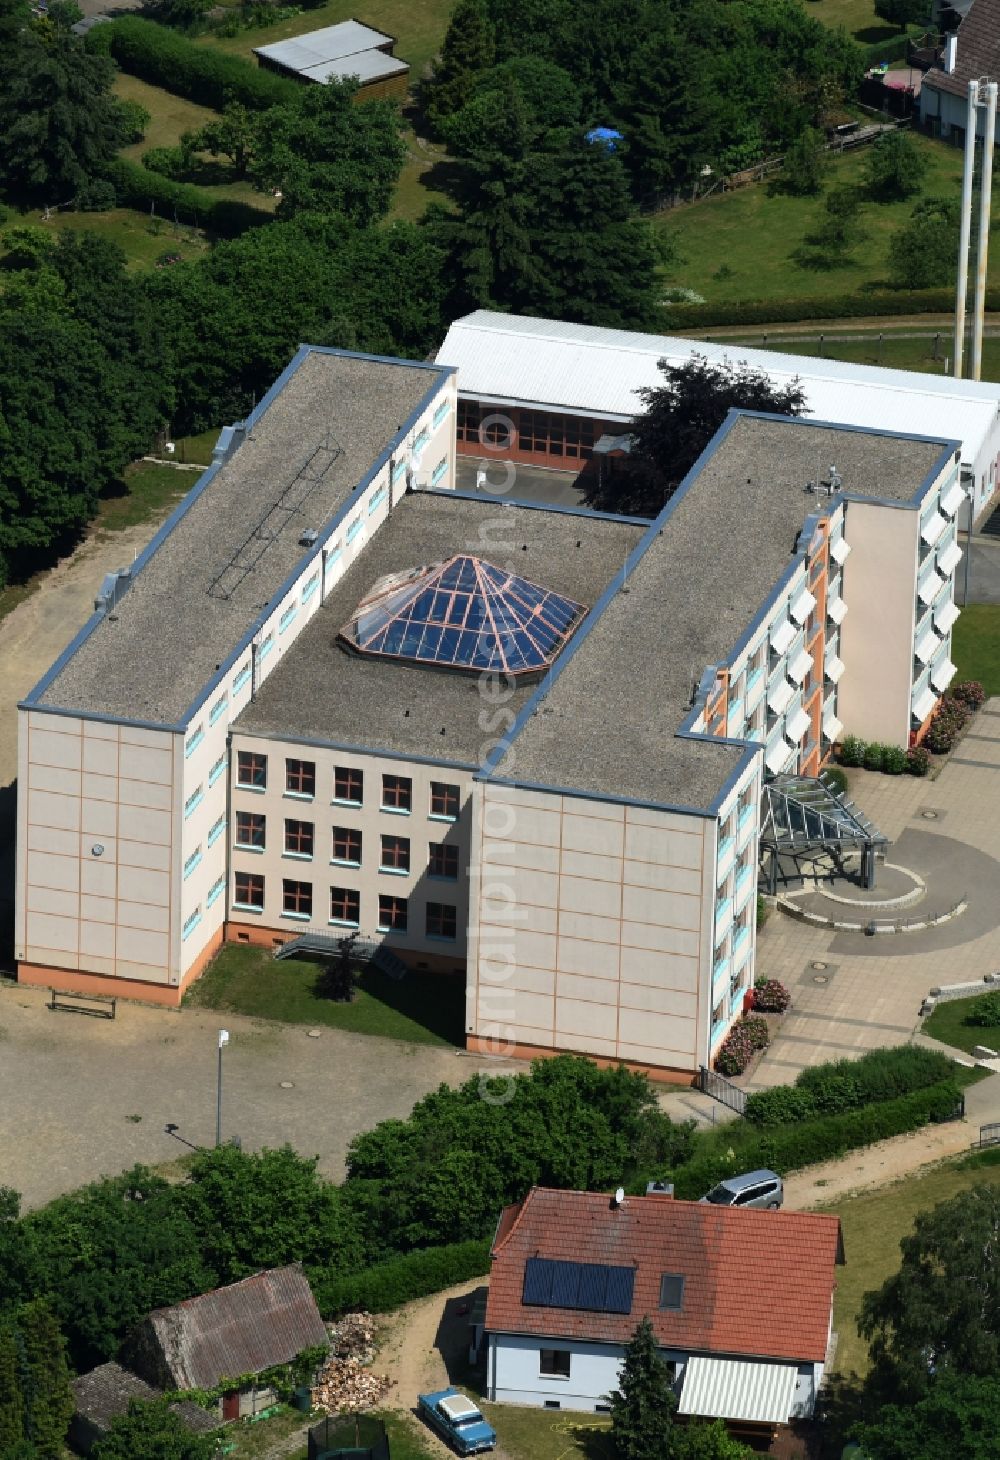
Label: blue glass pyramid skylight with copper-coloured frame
xmin=340 ymin=555 xmax=587 ymax=675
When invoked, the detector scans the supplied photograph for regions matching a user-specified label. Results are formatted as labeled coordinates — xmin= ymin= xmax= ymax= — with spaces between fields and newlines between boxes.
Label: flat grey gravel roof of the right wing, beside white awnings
xmin=495 ymin=416 xmax=955 ymax=809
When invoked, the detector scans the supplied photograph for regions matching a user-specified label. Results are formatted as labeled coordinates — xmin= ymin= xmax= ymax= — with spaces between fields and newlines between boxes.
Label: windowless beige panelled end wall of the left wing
xmin=15 ymin=710 xmax=180 ymax=986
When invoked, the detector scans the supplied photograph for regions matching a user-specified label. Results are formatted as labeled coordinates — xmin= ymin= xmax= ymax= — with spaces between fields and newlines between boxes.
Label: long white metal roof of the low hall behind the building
xmin=438 ymin=310 xmax=1000 ymax=461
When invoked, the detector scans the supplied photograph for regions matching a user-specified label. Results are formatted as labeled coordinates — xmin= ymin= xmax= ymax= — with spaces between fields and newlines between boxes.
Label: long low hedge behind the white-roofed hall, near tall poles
xmin=654 ymin=287 xmax=1000 ymax=331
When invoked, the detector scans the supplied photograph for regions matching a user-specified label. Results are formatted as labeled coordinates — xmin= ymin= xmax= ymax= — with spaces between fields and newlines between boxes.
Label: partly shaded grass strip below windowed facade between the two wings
xmin=185 ymin=943 xmax=466 ymax=1044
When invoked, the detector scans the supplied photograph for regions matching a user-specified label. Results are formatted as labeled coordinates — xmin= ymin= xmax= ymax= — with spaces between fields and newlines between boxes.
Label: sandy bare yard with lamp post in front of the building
xmin=0 ymin=986 xmax=511 ymax=1206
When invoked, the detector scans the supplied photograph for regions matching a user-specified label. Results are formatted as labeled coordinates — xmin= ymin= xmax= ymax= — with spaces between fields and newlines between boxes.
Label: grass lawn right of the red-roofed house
xmin=822 ymin=1152 xmax=1000 ymax=1377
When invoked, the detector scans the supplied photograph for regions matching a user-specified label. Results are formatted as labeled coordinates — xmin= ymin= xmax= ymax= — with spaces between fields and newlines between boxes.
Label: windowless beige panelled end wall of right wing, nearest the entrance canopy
xmin=466 ymin=783 xmax=717 ymax=1072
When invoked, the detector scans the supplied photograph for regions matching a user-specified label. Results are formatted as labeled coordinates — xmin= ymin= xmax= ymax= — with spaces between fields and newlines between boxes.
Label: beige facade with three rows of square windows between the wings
xmin=228 ymin=731 xmax=472 ymax=965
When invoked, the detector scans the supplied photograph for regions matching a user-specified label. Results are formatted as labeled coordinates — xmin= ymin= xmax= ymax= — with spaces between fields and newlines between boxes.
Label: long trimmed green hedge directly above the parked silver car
xmin=660 ymin=1079 xmax=961 ymax=1202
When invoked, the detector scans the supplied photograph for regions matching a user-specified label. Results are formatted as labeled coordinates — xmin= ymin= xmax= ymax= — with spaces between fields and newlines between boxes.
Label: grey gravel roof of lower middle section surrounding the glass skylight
xmin=234 ymin=492 xmax=645 ymax=767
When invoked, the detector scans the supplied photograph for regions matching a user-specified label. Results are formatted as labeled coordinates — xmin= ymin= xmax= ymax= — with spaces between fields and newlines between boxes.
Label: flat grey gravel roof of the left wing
xmin=38 ymin=350 xmax=445 ymax=724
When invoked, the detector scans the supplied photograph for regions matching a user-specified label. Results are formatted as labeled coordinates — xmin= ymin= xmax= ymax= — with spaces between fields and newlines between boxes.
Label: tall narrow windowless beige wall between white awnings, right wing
xmin=836 ymin=502 xmax=920 ymax=746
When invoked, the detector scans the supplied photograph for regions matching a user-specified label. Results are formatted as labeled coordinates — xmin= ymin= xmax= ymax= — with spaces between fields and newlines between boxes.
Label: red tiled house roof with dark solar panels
xmin=486 ymin=1187 xmax=844 ymax=1362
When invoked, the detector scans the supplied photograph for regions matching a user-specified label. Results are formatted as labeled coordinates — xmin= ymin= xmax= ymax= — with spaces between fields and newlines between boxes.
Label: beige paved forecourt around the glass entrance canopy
xmin=753 ymin=699 xmax=1000 ymax=1086
